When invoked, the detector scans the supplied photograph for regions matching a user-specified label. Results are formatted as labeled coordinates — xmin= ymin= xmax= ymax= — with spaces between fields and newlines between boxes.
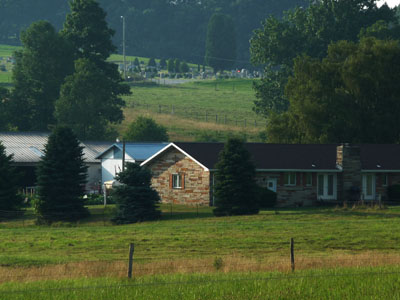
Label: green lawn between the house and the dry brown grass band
xmin=0 ymin=205 xmax=400 ymax=266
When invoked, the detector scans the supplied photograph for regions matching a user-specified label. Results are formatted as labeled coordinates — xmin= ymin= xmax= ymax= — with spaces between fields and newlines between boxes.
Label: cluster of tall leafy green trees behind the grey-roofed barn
xmin=0 ymin=0 xmax=130 ymax=139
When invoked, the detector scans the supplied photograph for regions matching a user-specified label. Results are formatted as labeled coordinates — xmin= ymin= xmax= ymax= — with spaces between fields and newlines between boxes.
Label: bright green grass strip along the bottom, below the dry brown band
xmin=0 ymin=267 xmax=400 ymax=300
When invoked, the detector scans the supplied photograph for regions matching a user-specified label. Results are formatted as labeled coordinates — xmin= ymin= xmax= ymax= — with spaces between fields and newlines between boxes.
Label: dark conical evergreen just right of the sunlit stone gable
xmin=213 ymin=139 xmax=259 ymax=216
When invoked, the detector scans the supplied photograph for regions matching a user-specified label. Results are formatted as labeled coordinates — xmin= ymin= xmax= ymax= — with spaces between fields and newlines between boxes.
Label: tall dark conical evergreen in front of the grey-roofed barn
xmin=35 ymin=127 xmax=88 ymax=223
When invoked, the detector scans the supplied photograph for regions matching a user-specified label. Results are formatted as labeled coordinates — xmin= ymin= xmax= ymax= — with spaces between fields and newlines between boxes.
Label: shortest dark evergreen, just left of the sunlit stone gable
xmin=112 ymin=163 xmax=161 ymax=224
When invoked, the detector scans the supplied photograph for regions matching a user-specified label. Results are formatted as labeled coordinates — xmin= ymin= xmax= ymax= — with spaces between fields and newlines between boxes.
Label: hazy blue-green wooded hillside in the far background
xmin=0 ymin=0 xmax=308 ymax=64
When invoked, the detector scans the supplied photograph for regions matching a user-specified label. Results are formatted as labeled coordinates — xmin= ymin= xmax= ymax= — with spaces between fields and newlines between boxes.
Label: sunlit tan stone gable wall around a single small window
xmin=148 ymin=147 xmax=210 ymax=206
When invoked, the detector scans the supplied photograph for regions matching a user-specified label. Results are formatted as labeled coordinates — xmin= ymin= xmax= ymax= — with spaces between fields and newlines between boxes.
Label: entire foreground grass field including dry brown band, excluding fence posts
xmin=0 ymin=205 xmax=400 ymax=300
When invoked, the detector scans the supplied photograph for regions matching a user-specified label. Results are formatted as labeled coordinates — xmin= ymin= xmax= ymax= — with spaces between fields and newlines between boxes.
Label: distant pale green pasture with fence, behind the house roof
xmin=118 ymin=79 xmax=265 ymax=141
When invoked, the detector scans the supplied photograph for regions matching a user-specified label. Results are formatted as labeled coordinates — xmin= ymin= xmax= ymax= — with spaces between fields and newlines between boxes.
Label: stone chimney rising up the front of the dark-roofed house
xmin=336 ymin=144 xmax=362 ymax=201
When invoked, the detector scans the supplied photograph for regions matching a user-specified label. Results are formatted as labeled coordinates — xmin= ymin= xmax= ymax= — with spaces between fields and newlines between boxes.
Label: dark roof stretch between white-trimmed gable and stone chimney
xmin=174 ymin=143 xmax=337 ymax=171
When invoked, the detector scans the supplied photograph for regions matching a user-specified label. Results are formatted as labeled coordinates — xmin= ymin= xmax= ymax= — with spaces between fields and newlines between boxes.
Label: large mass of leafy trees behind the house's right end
xmin=251 ymin=0 xmax=400 ymax=143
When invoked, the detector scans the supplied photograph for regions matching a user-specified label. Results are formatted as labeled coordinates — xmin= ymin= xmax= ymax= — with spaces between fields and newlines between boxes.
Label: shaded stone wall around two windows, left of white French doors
xmin=256 ymin=172 xmax=317 ymax=207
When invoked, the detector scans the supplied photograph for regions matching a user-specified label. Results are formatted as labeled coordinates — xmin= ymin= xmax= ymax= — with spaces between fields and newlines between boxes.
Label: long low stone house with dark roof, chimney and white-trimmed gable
xmin=141 ymin=143 xmax=400 ymax=206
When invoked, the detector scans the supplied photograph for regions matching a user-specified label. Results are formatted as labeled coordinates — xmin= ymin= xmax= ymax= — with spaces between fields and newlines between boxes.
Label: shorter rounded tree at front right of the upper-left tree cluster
xmin=56 ymin=59 xmax=129 ymax=139
